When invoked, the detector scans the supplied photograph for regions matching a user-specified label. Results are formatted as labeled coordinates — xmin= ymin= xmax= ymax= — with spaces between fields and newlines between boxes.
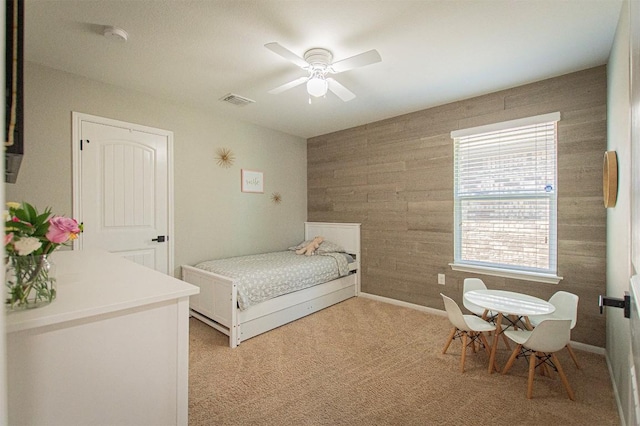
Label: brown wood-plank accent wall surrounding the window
xmin=307 ymin=66 xmax=608 ymax=347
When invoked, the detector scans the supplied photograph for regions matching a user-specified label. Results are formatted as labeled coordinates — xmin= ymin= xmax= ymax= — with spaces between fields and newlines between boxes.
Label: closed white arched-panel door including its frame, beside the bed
xmin=73 ymin=113 xmax=173 ymax=273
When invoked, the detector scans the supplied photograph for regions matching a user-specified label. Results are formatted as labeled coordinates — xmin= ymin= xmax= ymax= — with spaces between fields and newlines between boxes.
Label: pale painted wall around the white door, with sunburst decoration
xmin=5 ymin=62 xmax=307 ymax=274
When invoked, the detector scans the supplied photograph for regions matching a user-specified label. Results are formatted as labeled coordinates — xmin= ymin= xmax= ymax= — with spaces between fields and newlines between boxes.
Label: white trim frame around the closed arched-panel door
xmin=71 ymin=111 xmax=174 ymax=275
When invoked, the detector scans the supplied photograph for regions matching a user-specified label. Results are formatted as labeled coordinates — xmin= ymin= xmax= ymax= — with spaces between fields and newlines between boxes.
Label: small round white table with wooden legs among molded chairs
xmin=464 ymin=289 xmax=556 ymax=373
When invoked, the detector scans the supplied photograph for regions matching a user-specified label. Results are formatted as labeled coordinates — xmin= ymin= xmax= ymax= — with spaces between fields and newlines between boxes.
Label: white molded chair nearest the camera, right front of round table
xmin=502 ymin=319 xmax=574 ymax=401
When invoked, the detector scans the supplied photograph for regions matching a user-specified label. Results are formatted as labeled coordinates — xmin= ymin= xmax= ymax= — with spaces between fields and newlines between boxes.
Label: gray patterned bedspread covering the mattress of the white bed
xmin=196 ymin=251 xmax=349 ymax=310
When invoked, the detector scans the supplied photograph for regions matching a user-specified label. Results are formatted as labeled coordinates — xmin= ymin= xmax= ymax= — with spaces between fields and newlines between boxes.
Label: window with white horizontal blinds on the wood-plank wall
xmin=451 ymin=113 xmax=560 ymax=283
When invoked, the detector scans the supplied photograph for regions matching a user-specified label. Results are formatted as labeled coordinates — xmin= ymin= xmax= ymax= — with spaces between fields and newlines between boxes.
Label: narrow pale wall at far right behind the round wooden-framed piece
xmin=606 ymin=1 xmax=632 ymax=423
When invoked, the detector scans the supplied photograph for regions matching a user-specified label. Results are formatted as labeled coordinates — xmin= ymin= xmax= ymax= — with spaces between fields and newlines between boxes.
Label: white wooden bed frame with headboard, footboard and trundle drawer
xmin=182 ymin=222 xmax=361 ymax=348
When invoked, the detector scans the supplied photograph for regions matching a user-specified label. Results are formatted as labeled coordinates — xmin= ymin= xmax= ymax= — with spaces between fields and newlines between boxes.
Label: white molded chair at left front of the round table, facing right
xmin=440 ymin=293 xmax=496 ymax=373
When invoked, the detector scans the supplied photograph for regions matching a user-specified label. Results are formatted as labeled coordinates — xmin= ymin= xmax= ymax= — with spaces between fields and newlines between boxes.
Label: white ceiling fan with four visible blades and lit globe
xmin=264 ymin=42 xmax=382 ymax=103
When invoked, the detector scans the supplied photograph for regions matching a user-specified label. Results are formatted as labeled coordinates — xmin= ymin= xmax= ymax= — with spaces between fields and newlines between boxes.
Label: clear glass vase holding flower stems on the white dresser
xmin=5 ymin=254 xmax=56 ymax=311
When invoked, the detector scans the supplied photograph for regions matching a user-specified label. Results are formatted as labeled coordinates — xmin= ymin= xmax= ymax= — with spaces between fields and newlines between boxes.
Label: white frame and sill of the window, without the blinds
xmin=449 ymin=112 xmax=562 ymax=284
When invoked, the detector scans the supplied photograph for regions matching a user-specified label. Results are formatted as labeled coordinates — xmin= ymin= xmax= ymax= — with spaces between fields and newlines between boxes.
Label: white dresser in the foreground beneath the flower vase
xmin=6 ymin=250 xmax=198 ymax=426
